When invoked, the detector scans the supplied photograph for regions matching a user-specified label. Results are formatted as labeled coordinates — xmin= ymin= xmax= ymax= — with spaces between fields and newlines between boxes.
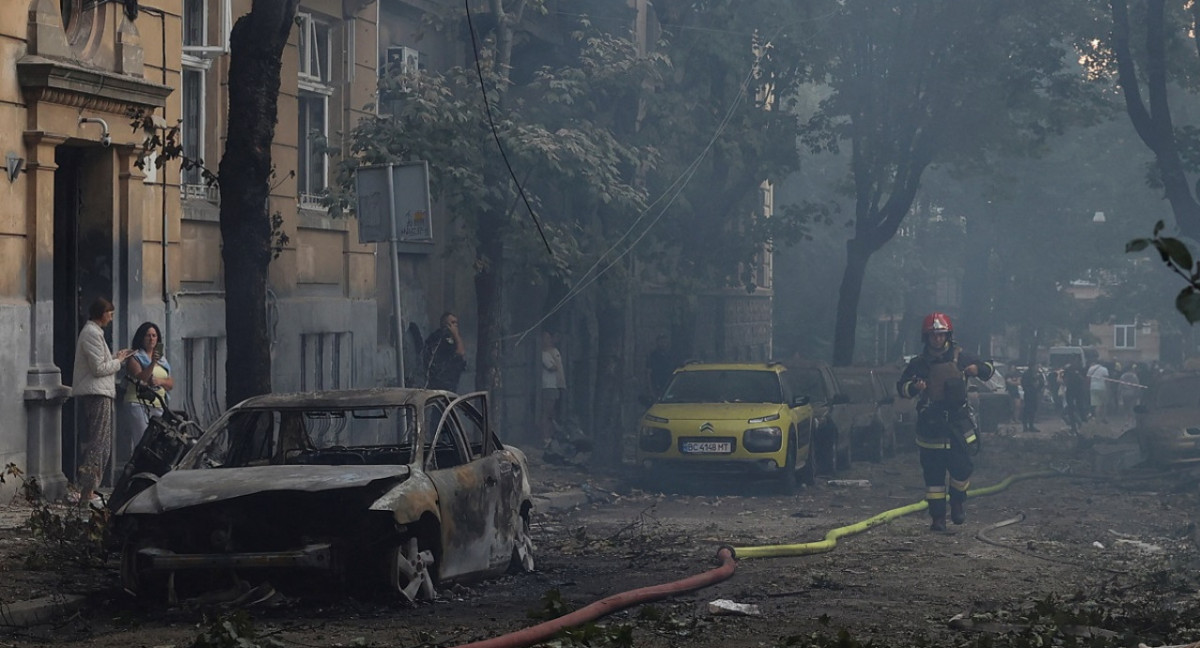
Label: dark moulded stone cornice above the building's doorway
xmin=17 ymin=55 xmax=174 ymax=114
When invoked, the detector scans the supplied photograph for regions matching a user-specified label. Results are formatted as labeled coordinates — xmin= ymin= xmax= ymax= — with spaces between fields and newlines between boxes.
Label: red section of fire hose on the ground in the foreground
xmin=458 ymin=547 xmax=737 ymax=648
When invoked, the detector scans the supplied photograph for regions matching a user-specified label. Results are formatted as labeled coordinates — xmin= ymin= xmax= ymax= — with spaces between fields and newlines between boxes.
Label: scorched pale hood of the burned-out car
xmin=119 ymin=466 xmax=409 ymax=515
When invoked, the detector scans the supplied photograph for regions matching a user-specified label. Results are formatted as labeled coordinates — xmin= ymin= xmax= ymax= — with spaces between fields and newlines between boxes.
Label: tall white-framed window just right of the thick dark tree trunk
xmin=296 ymin=12 xmax=334 ymax=209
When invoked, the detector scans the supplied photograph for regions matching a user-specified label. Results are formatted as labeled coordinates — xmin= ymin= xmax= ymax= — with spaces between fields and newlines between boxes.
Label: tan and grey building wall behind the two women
xmin=0 ymin=0 xmax=378 ymax=497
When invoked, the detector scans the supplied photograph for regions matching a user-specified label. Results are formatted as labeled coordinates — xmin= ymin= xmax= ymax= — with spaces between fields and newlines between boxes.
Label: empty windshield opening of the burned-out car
xmin=198 ymin=406 xmax=416 ymax=467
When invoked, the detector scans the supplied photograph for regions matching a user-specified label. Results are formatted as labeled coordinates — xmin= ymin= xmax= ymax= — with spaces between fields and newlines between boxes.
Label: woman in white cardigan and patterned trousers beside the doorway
xmin=71 ymin=298 xmax=132 ymax=506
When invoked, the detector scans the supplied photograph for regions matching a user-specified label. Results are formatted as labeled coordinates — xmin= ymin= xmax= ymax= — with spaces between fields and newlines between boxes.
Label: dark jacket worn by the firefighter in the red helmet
xmin=896 ymin=341 xmax=995 ymax=450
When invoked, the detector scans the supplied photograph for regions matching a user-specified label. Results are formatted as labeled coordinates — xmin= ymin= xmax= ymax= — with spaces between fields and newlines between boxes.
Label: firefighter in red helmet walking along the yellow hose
xmin=896 ymin=313 xmax=995 ymax=532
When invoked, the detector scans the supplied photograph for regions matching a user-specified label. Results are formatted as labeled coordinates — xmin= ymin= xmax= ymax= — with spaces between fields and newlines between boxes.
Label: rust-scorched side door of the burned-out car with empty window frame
xmin=425 ymin=392 xmax=520 ymax=578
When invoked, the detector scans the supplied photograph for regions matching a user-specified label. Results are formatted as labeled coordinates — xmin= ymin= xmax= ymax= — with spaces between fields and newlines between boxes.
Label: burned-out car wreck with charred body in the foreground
xmin=113 ymin=389 xmax=533 ymax=601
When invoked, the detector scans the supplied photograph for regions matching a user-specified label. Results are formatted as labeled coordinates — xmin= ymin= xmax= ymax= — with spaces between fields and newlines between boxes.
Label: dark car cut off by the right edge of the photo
xmin=1126 ymin=372 xmax=1200 ymax=464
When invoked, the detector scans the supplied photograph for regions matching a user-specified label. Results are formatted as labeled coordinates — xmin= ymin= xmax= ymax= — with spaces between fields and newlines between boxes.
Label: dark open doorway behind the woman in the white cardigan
xmin=54 ymin=145 xmax=115 ymax=481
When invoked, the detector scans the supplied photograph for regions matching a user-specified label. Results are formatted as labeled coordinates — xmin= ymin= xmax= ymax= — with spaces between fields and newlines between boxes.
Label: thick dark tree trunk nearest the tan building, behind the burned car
xmin=220 ymin=0 xmax=299 ymax=406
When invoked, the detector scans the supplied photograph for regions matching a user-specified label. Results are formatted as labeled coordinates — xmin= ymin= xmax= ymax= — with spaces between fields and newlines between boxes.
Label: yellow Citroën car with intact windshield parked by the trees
xmin=637 ymin=362 xmax=815 ymax=493
